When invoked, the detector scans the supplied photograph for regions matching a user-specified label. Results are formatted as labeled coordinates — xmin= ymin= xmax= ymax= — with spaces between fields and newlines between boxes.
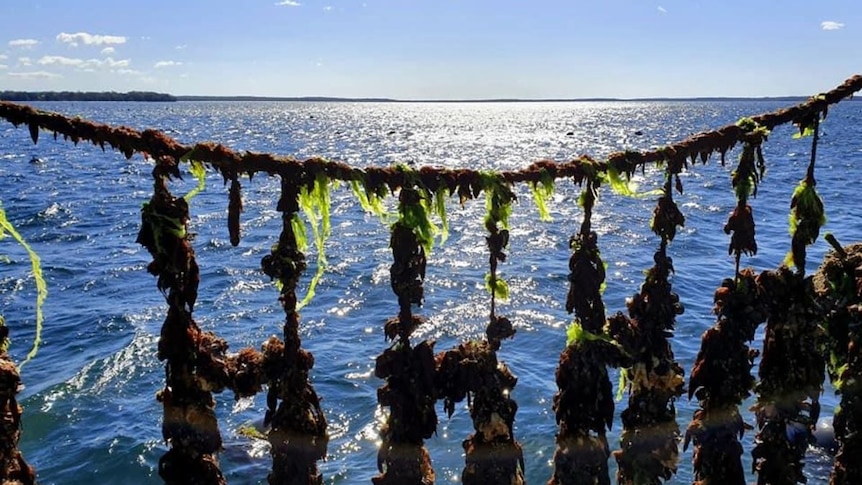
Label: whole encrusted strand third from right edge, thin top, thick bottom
xmin=684 ymin=118 xmax=769 ymax=485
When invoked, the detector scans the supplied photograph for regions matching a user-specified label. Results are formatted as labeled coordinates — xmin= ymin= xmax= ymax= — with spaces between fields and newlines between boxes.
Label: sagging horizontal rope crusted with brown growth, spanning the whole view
xmin=0 ymin=75 xmax=862 ymax=194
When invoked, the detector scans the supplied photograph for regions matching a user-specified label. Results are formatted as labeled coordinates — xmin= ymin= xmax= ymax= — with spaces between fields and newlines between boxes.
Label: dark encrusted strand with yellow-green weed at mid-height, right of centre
xmin=548 ymin=176 xmax=631 ymax=485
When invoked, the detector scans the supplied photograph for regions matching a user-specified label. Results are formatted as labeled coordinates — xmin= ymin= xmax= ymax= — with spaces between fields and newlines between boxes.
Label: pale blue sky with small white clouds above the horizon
xmin=0 ymin=0 xmax=862 ymax=99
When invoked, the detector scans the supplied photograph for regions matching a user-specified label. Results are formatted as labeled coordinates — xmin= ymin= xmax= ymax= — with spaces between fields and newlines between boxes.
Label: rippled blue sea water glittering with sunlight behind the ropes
xmin=0 ymin=96 xmax=862 ymax=485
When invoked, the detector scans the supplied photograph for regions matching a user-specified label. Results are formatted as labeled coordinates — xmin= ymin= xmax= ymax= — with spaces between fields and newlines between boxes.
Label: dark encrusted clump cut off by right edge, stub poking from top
xmin=813 ymin=234 xmax=862 ymax=485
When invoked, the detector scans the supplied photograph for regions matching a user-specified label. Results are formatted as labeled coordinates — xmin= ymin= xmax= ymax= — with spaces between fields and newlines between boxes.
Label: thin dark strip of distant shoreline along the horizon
xmin=0 ymin=91 xmax=860 ymax=103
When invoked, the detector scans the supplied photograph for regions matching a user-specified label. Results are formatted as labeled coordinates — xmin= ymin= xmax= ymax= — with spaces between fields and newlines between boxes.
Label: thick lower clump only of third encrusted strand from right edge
xmin=684 ymin=269 xmax=767 ymax=485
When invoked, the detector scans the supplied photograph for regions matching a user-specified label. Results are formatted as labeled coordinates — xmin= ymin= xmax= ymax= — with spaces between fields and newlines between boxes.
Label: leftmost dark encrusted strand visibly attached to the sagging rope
xmin=137 ymin=157 xmax=229 ymax=485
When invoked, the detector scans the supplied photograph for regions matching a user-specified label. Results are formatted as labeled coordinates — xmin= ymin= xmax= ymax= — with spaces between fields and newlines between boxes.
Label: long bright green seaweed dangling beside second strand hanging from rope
xmin=300 ymin=172 xmax=332 ymax=311
